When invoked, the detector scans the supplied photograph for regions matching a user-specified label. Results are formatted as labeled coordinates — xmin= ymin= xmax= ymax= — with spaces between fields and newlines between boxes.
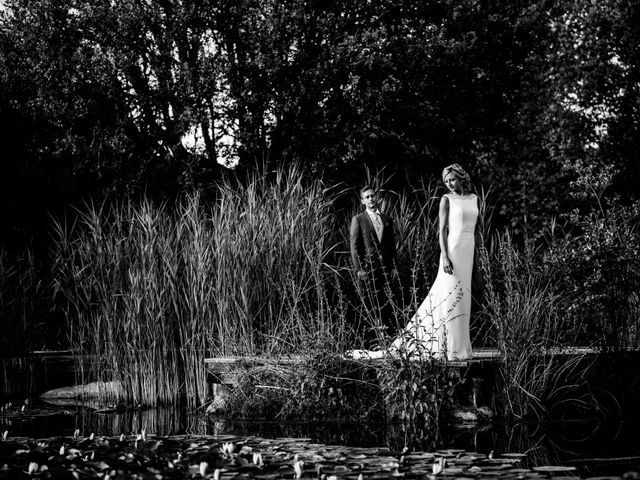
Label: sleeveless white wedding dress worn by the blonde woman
xmin=393 ymin=194 xmax=478 ymax=360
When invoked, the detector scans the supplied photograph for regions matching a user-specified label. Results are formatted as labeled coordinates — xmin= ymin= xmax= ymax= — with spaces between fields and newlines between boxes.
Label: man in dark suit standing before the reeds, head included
xmin=349 ymin=185 xmax=398 ymax=338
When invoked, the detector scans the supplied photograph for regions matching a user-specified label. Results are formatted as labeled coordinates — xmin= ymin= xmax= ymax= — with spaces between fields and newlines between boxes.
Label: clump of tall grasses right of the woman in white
xmin=479 ymin=233 xmax=585 ymax=420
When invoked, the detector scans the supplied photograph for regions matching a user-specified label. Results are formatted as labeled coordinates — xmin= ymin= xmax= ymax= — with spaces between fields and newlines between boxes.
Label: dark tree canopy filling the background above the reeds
xmin=0 ymin=0 xmax=640 ymax=242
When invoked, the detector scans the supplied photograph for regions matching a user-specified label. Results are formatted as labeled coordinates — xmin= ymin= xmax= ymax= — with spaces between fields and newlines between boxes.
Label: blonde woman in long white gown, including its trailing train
xmin=353 ymin=163 xmax=479 ymax=360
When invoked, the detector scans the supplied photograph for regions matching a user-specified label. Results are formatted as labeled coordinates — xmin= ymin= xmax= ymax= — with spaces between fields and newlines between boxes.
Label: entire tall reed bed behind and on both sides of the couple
xmin=48 ymin=162 xmax=608 ymax=417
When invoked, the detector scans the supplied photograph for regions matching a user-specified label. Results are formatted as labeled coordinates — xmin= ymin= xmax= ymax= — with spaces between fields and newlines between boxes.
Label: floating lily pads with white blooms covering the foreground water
xmin=0 ymin=431 xmax=612 ymax=480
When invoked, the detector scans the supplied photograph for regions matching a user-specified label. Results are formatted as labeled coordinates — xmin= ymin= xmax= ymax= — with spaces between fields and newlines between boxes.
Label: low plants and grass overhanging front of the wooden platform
xmin=225 ymin=352 xmax=460 ymax=431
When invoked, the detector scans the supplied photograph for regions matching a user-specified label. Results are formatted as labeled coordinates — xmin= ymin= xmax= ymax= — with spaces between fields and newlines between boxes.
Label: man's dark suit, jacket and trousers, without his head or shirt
xmin=349 ymin=211 xmax=396 ymax=341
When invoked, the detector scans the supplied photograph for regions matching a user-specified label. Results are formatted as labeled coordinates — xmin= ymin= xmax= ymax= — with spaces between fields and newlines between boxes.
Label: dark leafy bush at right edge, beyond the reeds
xmin=545 ymin=162 xmax=640 ymax=349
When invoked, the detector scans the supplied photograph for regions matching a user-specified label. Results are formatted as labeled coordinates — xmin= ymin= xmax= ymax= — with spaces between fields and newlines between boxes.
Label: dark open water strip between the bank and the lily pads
xmin=0 ymin=405 xmax=640 ymax=474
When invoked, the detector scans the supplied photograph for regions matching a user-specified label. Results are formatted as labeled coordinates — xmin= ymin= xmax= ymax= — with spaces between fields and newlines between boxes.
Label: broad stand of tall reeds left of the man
xmin=56 ymin=168 xmax=352 ymax=406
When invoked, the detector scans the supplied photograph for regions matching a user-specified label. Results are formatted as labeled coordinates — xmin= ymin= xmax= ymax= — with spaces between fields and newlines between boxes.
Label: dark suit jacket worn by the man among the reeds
xmin=349 ymin=212 xmax=396 ymax=272
